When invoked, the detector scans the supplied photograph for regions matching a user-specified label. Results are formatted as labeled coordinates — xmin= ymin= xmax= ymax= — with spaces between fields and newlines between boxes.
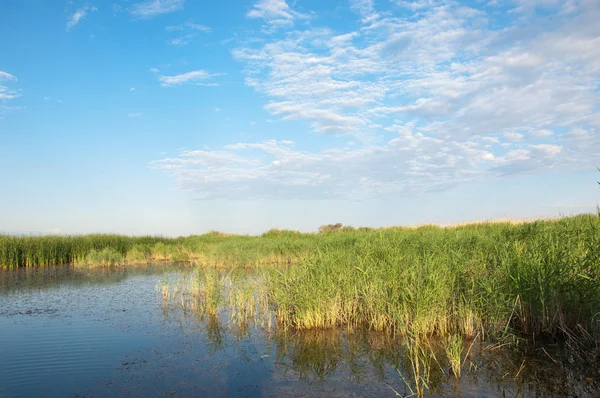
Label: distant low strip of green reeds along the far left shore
xmin=0 ymin=230 xmax=326 ymax=268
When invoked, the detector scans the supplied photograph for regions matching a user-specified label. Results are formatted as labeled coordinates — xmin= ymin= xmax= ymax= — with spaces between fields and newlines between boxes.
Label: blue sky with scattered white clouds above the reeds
xmin=0 ymin=0 xmax=600 ymax=236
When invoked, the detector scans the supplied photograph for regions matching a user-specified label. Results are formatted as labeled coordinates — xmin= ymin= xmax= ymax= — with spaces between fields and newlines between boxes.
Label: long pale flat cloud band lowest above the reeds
xmin=151 ymin=131 xmax=572 ymax=200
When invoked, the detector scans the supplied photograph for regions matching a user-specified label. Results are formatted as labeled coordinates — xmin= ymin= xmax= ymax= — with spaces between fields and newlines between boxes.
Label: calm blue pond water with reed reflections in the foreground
xmin=0 ymin=267 xmax=600 ymax=397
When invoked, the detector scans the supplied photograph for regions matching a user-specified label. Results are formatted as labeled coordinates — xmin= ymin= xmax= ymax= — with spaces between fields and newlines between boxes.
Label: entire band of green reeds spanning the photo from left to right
xmin=0 ymin=214 xmax=600 ymax=346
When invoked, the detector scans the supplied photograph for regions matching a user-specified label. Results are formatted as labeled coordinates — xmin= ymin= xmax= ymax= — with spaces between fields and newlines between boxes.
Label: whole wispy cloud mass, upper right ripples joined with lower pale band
xmin=152 ymin=0 xmax=600 ymax=199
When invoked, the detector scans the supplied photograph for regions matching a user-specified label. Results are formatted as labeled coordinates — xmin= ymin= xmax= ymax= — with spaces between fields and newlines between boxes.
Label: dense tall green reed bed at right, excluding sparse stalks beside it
xmin=270 ymin=215 xmax=600 ymax=339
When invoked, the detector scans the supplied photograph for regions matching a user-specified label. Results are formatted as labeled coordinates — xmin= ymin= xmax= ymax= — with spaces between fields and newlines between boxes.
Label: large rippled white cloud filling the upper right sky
xmin=233 ymin=0 xmax=600 ymax=141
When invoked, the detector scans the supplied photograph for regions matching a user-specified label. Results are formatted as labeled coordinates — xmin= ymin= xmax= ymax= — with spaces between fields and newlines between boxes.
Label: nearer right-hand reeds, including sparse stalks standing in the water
xmin=145 ymin=215 xmax=600 ymax=396
